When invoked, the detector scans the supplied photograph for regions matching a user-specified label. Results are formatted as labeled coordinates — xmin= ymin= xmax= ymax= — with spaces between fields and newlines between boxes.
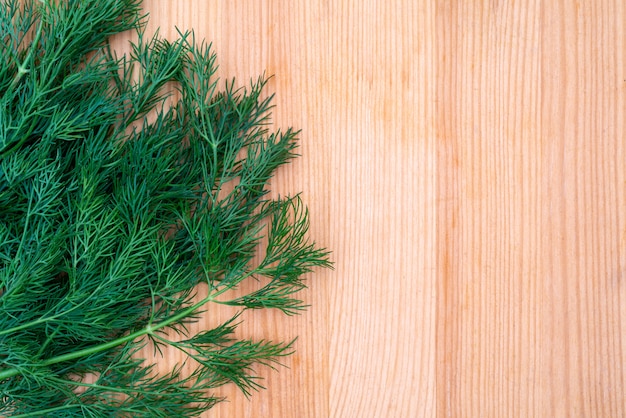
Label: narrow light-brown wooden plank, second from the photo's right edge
xmin=437 ymin=2 xmax=542 ymax=417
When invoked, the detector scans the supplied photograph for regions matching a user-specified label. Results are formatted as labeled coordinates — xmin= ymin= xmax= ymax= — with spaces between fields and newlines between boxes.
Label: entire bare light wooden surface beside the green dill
xmin=123 ymin=0 xmax=626 ymax=418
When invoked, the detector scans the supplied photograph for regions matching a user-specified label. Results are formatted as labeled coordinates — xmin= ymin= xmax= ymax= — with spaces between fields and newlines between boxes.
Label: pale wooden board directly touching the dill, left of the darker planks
xmin=128 ymin=1 xmax=435 ymax=417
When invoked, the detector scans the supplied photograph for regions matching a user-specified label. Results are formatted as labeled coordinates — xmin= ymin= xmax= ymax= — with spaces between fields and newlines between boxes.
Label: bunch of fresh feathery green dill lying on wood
xmin=0 ymin=0 xmax=330 ymax=417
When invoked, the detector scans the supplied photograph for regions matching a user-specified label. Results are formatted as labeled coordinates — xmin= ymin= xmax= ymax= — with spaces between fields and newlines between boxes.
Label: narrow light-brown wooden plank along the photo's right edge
xmin=538 ymin=1 xmax=626 ymax=416
